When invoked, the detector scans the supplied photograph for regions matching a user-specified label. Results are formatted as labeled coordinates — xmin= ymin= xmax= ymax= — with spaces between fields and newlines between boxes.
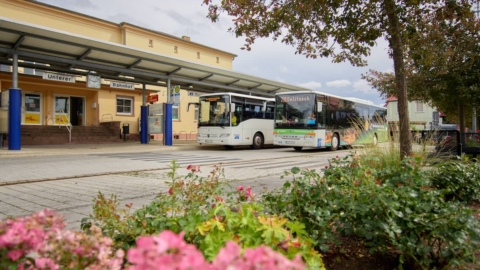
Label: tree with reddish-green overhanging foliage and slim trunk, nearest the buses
xmin=204 ymin=0 xmax=449 ymax=158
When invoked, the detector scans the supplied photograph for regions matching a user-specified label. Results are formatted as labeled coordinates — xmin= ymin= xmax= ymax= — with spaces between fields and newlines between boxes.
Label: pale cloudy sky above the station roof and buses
xmin=38 ymin=0 xmax=393 ymax=106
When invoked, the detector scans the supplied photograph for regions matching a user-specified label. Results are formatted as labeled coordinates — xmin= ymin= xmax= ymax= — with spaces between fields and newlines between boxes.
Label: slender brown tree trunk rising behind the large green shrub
xmin=383 ymin=0 xmax=412 ymax=159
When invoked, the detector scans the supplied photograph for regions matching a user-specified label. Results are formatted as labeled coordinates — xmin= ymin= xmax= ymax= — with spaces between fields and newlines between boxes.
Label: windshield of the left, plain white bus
xmin=198 ymin=95 xmax=230 ymax=127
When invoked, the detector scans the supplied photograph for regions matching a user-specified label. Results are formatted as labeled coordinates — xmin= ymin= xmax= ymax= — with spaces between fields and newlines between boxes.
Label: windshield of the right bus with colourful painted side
xmin=275 ymin=93 xmax=317 ymax=128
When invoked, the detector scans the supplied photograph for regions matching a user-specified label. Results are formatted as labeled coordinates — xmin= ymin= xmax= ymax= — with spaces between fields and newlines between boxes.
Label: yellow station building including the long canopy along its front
xmin=0 ymin=0 xmax=305 ymax=144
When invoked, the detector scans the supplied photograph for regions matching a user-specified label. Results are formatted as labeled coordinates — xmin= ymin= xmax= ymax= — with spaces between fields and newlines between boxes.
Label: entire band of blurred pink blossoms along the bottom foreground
xmin=0 ymin=210 xmax=305 ymax=270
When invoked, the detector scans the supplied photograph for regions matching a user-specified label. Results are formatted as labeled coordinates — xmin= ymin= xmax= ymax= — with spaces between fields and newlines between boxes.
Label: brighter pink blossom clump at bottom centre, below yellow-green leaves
xmin=126 ymin=231 xmax=306 ymax=270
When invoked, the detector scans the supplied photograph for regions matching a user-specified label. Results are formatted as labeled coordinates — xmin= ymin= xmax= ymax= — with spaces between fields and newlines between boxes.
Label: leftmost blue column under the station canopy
xmin=8 ymin=88 xmax=22 ymax=150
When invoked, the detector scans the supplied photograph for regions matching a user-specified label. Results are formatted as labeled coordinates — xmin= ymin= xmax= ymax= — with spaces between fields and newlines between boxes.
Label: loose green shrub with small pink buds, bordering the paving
xmin=82 ymin=161 xmax=228 ymax=250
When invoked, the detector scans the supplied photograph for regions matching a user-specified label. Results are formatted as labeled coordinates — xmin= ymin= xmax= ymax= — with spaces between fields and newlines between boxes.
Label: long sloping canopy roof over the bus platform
xmin=0 ymin=17 xmax=309 ymax=96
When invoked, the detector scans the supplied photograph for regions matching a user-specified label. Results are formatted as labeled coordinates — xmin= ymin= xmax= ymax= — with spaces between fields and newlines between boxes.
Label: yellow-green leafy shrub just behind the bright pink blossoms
xmin=197 ymin=202 xmax=325 ymax=270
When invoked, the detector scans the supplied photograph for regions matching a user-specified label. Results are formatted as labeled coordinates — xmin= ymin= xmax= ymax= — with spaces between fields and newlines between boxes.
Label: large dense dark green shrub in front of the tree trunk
xmin=263 ymin=153 xmax=480 ymax=268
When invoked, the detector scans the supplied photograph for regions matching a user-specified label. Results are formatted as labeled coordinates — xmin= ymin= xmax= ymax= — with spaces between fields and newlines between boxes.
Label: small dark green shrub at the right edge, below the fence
xmin=430 ymin=161 xmax=480 ymax=203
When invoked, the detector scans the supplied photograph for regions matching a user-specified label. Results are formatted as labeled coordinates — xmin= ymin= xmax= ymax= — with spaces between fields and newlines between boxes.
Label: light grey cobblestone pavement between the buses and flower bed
xmin=0 ymin=141 xmax=349 ymax=230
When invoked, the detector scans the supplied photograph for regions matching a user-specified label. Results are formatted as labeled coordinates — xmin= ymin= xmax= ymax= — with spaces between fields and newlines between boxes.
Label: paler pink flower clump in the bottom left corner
xmin=0 ymin=210 xmax=124 ymax=269
